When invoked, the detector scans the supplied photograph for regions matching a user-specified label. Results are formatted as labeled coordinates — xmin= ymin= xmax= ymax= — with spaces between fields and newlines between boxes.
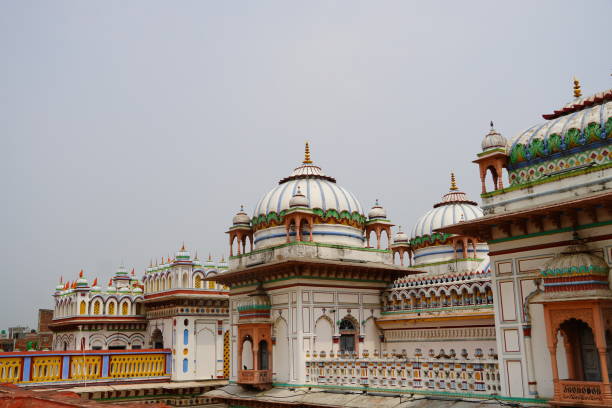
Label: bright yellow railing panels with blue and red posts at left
xmin=0 ymin=349 xmax=171 ymax=386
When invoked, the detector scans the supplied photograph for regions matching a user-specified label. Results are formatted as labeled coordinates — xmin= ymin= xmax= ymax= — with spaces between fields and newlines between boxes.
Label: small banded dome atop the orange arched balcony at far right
xmin=540 ymin=237 xmax=610 ymax=292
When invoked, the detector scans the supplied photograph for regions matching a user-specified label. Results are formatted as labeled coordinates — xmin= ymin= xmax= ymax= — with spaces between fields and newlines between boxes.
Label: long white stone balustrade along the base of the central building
xmin=306 ymin=353 xmax=501 ymax=395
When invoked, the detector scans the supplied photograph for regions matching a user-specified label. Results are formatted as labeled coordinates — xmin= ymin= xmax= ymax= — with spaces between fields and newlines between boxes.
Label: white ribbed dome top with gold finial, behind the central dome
xmin=411 ymin=175 xmax=483 ymax=238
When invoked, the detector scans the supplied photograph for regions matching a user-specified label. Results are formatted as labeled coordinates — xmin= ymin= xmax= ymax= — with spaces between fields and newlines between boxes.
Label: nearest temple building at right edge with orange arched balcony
xmin=438 ymin=81 xmax=612 ymax=406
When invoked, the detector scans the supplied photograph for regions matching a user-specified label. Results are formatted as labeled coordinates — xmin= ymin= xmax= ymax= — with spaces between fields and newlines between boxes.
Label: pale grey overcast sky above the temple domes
xmin=0 ymin=0 xmax=612 ymax=328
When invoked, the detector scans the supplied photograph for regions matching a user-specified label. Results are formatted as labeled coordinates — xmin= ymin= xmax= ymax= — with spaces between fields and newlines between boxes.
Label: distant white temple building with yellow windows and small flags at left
xmin=49 ymin=245 xmax=230 ymax=381
